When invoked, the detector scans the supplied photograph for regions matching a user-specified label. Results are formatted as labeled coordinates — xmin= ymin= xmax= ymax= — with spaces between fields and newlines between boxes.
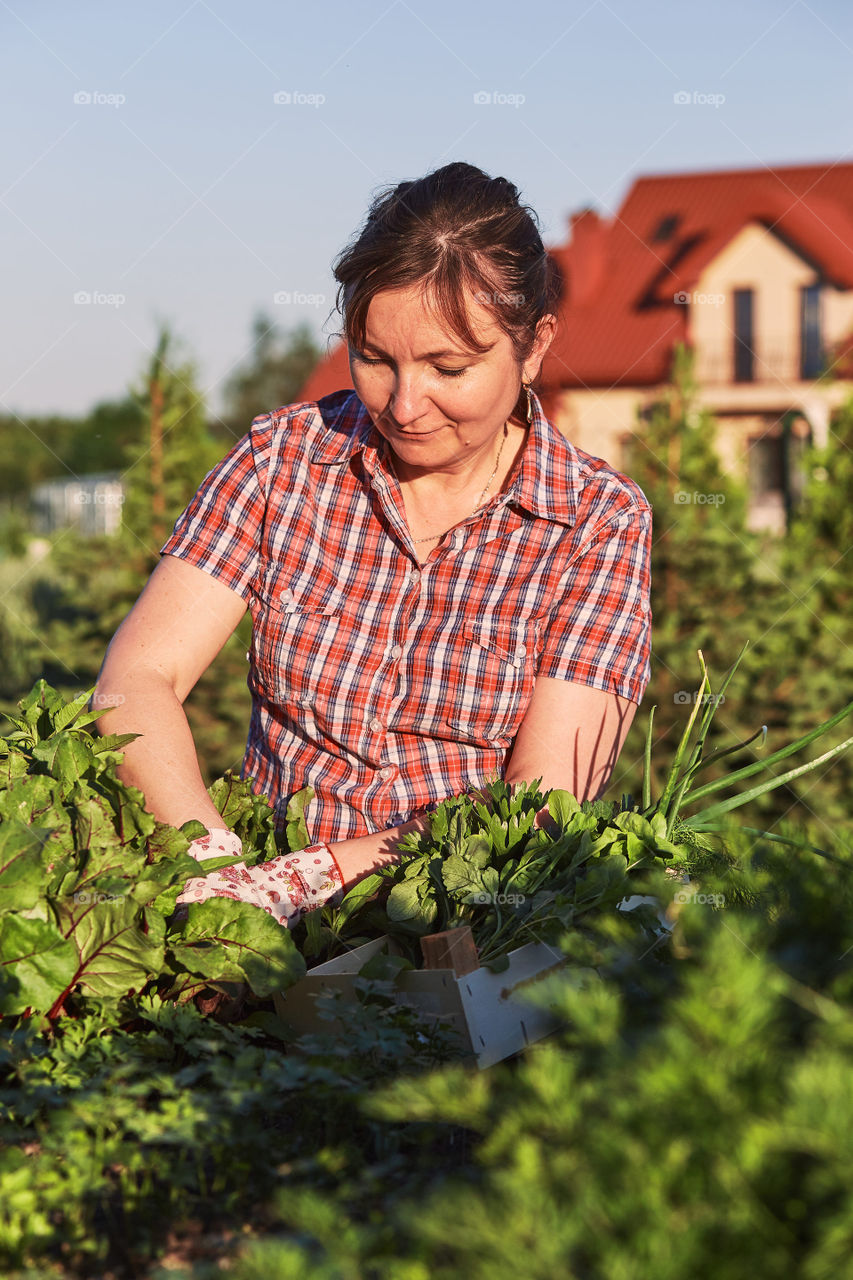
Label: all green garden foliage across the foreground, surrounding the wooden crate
xmin=0 ymin=676 xmax=853 ymax=1280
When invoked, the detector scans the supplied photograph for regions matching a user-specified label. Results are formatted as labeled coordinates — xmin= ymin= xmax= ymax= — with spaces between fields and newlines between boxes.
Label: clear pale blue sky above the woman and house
xmin=0 ymin=0 xmax=853 ymax=425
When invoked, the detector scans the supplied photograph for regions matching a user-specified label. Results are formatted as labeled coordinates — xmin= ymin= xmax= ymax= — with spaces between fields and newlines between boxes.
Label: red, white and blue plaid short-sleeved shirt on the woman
xmin=161 ymin=390 xmax=652 ymax=842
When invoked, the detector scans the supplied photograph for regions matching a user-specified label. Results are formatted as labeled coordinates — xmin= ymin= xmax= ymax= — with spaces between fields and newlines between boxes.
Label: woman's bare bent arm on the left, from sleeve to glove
xmin=92 ymin=556 xmax=246 ymax=828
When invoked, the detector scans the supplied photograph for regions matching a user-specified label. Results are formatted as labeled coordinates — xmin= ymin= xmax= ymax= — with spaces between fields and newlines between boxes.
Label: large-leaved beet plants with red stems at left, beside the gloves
xmin=0 ymin=680 xmax=305 ymax=1019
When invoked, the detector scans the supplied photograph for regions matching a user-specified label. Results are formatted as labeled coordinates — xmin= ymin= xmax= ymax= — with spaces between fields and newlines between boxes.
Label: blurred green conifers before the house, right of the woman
xmin=611 ymin=348 xmax=853 ymax=824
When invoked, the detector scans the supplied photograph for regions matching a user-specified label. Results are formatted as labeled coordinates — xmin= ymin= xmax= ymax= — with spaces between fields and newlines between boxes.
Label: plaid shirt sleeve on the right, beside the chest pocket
xmin=537 ymin=507 xmax=652 ymax=705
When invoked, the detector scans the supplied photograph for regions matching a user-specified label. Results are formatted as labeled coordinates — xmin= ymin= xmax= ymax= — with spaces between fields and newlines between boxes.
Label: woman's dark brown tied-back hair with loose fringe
xmin=334 ymin=160 xmax=558 ymax=364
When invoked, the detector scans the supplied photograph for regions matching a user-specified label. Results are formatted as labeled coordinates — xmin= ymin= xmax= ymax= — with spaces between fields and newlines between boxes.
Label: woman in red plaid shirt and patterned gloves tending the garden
xmin=96 ymin=163 xmax=651 ymax=924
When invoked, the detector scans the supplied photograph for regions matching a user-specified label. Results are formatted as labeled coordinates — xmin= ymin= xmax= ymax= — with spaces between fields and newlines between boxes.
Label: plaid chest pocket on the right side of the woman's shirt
xmin=444 ymin=618 xmax=537 ymax=746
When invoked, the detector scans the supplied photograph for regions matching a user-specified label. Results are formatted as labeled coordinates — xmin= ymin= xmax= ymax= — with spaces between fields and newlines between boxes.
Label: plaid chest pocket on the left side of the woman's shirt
xmin=251 ymin=562 xmax=348 ymax=710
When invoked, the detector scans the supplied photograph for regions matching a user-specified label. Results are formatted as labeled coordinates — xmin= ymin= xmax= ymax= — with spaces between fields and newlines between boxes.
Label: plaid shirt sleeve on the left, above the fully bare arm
xmin=160 ymin=419 xmax=266 ymax=600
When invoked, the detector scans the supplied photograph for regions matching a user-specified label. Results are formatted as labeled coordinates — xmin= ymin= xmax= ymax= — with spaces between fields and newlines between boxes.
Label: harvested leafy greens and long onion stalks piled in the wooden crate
xmin=297 ymin=645 xmax=853 ymax=969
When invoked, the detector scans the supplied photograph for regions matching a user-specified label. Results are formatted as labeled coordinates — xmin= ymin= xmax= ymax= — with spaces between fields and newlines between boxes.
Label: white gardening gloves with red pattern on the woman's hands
xmin=177 ymin=827 xmax=343 ymax=929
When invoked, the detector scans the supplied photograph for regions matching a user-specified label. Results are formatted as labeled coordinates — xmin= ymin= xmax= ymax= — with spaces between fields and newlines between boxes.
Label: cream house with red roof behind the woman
xmin=295 ymin=164 xmax=853 ymax=531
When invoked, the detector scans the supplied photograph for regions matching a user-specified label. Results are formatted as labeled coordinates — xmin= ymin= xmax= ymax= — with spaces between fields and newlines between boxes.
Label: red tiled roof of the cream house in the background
xmin=295 ymin=164 xmax=853 ymax=396
